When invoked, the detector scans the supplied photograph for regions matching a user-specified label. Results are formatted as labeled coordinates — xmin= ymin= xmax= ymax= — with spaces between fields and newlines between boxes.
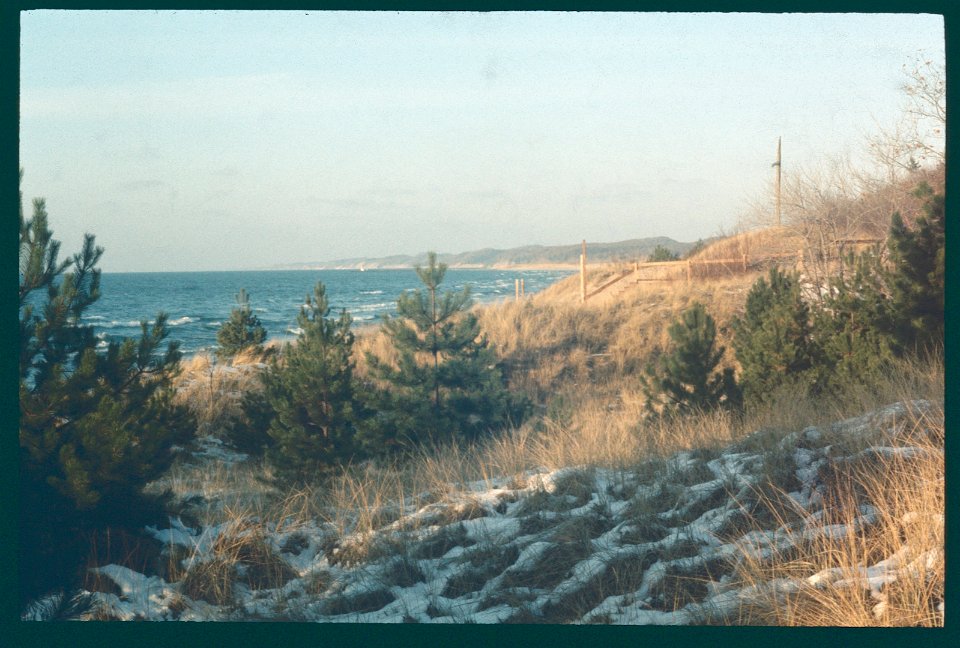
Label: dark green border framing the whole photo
xmin=0 ymin=5 xmax=960 ymax=648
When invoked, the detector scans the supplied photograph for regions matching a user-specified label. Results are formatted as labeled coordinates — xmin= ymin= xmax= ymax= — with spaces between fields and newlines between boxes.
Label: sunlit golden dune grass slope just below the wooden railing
xmin=478 ymin=272 xmax=759 ymax=404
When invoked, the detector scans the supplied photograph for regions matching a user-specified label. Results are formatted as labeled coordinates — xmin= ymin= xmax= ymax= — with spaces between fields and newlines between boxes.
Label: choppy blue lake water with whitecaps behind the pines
xmin=84 ymin=269 xmax=571 ymax=355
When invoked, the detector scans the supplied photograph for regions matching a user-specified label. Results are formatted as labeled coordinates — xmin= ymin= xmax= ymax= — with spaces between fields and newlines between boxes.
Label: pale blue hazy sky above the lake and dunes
xmin=20 ymin=10 xmax=944 ymax=272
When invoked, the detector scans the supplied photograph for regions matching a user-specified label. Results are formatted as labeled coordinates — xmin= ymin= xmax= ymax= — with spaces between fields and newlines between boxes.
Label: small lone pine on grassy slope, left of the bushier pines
xmin=642 ymin=302 xmax=741 ymax=416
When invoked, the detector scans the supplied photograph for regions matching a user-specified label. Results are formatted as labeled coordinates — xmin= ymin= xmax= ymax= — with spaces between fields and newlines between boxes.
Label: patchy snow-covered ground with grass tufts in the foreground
xmin=24 ymin=401 xmax=943 ymax=624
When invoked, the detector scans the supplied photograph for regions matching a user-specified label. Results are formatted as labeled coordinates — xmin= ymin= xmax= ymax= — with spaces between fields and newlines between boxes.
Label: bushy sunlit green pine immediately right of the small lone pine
xmin=733 ymin=268 xmax=817 ymax=403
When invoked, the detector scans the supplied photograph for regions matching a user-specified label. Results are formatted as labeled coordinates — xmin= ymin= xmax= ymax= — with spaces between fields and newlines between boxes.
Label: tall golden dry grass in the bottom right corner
xmin=739 ymin=411 xmax=945 ymax=627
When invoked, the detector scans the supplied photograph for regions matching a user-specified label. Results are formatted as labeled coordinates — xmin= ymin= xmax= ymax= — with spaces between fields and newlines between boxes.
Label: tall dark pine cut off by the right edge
xmin=888 ymin=183 xmax=946 ymax=352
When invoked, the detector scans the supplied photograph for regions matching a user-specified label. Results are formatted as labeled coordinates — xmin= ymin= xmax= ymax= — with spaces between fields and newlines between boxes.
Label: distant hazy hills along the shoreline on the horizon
xmin=274 ymin=236 xmax=695 ymax=270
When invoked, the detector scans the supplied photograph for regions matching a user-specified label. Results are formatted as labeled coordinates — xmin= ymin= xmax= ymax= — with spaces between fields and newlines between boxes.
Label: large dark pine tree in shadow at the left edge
xmin=19 ymin=176 xmax=193 ymax=597
